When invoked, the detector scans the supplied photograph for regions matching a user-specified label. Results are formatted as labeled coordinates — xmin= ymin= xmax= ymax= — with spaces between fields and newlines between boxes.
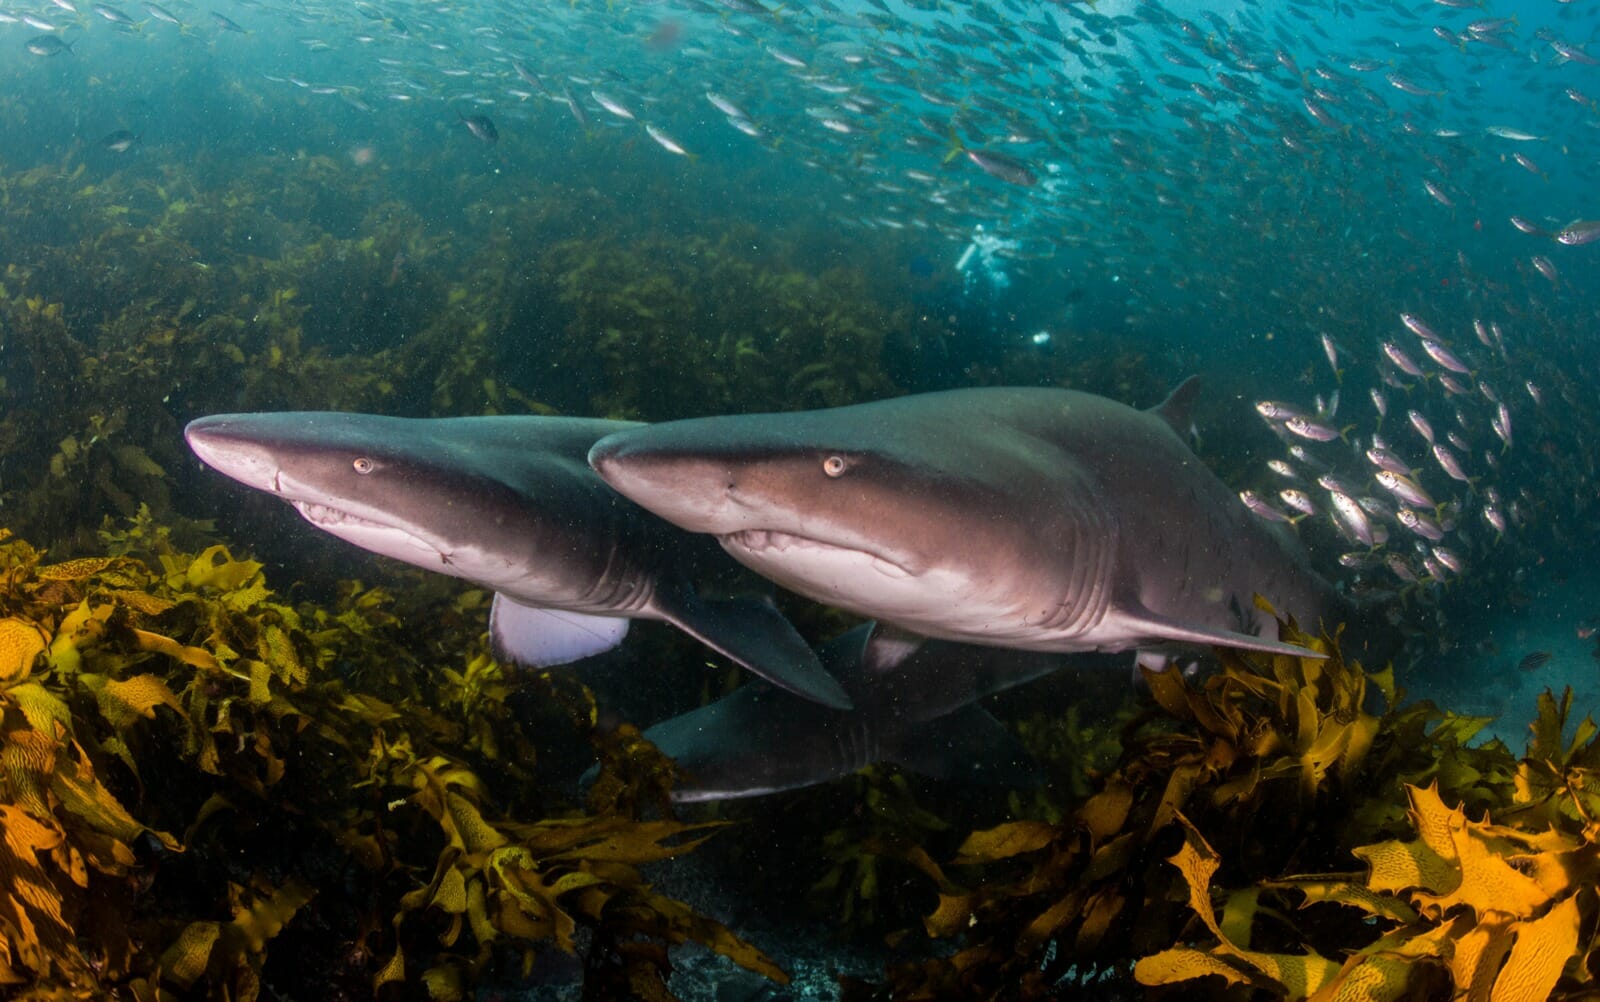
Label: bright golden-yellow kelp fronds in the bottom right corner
xmin=1134 ymin=688 xmax=1600 ymax=1002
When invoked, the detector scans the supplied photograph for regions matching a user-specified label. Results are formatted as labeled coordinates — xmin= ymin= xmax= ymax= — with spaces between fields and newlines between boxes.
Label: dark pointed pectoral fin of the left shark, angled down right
xmin=662 ymin=589 xmax=851 ymax=709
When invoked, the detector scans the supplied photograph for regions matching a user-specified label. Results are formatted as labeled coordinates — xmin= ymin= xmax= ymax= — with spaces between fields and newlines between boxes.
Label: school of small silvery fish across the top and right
xmin=0 ymin=0 xmax=1600 ymax=643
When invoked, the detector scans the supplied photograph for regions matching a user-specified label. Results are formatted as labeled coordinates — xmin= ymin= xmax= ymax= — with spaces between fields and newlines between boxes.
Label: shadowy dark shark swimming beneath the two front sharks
xmin=645 ymin=623 xmax=1064 ymax=804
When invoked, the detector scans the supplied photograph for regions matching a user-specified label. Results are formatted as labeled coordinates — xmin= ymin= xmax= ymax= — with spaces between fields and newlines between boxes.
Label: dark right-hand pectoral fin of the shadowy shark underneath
xmin=883 ymin=704 xmax=1043 ymax=786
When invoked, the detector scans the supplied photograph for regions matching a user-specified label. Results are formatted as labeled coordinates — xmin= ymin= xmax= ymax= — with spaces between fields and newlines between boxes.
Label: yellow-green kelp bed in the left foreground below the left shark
xmin=0 ymin=512 xmax=786 ymax=1000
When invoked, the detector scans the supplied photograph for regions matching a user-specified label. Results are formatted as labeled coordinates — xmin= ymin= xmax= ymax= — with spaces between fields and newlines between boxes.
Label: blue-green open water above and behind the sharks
xmin=0 ymin=0 xmax=1600 ymax=992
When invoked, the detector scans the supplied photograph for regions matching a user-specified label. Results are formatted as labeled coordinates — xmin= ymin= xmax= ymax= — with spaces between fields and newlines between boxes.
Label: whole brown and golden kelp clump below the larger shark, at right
xmin=862 ymin=605 xmax=1574 ymax=999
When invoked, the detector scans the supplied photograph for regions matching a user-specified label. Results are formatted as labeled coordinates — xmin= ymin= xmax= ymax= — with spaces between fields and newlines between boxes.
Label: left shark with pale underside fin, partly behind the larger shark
xmin=184 ymin=411 xmax=850 ymax=707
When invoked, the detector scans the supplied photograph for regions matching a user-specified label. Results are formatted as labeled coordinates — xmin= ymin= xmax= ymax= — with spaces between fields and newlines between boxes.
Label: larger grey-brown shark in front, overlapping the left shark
xmin=589 ymin=379 xmax=1352 ymax=656
